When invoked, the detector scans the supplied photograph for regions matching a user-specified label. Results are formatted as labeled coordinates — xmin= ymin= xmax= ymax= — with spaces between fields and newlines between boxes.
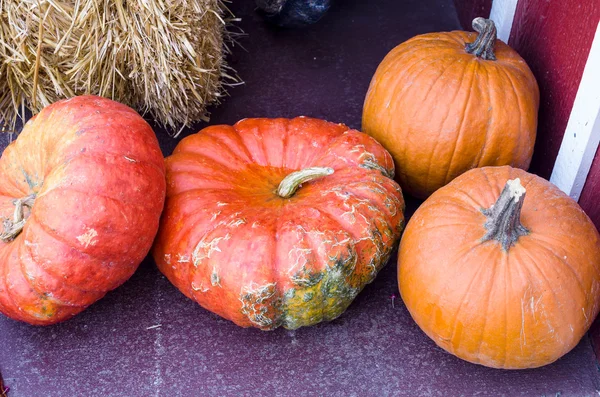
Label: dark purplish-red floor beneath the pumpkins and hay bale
xmin=0 ymin=0 xmax=600 ymax=397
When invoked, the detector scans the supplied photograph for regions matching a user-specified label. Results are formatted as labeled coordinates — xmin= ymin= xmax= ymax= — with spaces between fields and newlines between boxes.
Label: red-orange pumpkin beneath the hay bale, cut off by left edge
xmin=0 ymin=96 xmax=166 ymax=325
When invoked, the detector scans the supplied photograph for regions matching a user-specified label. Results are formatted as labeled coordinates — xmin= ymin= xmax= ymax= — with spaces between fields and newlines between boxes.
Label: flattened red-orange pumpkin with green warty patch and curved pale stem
xmin=153 ymin=117 xmax=404 ymax=330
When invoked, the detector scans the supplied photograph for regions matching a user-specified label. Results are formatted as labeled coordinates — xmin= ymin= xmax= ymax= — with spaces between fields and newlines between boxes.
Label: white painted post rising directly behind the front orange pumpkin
xmin=550 ymin=23 xmax=600 ymax=200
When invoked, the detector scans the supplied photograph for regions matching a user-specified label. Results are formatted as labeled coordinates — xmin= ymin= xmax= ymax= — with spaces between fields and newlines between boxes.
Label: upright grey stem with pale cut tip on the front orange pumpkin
xmin=481 ymin=178 xmax=529 ymax=251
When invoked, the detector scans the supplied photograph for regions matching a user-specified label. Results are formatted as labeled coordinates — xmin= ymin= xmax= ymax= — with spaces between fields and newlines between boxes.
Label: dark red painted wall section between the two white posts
xmin=509 ymin=0 xmax=600 ymax=178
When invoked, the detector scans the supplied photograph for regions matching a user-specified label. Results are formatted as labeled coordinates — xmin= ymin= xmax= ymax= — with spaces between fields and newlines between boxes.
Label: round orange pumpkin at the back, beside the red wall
xmin=362 ymin=18 xmax=539 ymax=198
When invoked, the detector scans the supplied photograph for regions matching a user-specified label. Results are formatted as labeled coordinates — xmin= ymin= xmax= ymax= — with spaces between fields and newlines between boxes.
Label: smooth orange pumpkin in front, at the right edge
xmin=398 ymin=166 xmax=600 ymax=369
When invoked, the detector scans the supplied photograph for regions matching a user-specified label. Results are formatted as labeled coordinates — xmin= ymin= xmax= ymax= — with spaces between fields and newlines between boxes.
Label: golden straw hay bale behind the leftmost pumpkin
xmin=0 ymin=0 xmax=236 ymax=134
